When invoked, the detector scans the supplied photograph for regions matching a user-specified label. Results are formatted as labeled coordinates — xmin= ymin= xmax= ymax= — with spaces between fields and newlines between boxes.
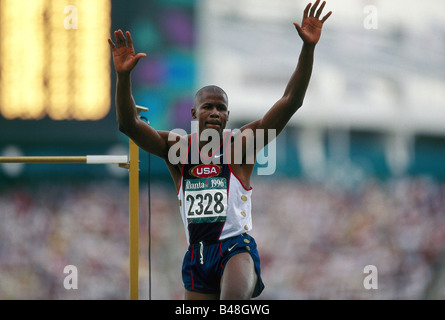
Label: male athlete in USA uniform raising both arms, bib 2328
xmin=108 ymin=0 xmax=332 ymax=300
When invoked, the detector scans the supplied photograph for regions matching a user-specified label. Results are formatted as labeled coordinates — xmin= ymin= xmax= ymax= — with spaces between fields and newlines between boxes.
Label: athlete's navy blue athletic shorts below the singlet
xmin=182 ymin=233 xmax=264 ymax=298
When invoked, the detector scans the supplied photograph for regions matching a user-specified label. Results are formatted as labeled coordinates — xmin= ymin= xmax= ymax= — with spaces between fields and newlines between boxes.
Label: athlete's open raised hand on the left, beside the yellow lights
xmin=108 ymin=30 xmax=147 ymax=73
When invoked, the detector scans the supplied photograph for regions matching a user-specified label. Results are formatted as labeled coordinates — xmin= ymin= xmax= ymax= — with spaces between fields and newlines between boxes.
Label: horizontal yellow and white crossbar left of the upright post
xmin=0 ymin=155 xmax=128 ymax=164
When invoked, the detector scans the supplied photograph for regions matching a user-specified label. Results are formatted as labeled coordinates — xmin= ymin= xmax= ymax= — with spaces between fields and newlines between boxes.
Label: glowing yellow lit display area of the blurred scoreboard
xmin=0 ymin=0 xmax=111 ymax=120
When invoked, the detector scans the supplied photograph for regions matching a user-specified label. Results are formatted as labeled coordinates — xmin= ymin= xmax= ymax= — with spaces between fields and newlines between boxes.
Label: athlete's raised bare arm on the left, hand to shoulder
xmin=108 ymin=30 xmax=174 ymax=159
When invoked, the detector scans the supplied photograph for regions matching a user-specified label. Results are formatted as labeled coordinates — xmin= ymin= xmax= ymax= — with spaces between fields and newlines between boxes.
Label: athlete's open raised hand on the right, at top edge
xmin=294 ymin=0 xmax=332 ymax=45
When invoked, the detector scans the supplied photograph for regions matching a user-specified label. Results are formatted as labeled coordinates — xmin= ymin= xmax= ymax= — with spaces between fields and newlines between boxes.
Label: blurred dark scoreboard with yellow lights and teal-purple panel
xmin=0 ymin=0 xmax=195 ymax=180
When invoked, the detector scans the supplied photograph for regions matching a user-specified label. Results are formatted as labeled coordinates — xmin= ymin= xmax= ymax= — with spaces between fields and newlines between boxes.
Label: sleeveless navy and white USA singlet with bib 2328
xmin=177 ymin=133 xmax=252 ymax=244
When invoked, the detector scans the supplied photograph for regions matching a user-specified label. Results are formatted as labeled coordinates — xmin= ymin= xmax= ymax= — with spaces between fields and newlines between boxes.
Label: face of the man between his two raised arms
xmin=192 ymin=91 xmax=229 ymax=134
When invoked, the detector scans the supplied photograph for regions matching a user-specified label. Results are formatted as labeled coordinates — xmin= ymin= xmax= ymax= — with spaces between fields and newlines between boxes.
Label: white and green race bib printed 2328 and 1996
xmin=184 ymin=177 xmax=227 ymax=224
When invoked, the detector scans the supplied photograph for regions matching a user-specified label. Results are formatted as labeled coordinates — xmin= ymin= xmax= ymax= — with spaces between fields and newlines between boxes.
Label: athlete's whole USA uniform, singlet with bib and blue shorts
xmin=177 ymin=133 xmax=264 ymax=297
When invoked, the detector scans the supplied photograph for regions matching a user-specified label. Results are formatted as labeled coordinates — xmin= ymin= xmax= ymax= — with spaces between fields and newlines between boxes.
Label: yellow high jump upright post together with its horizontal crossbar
xmin=0 ymin=106 xmax=148 ymax=300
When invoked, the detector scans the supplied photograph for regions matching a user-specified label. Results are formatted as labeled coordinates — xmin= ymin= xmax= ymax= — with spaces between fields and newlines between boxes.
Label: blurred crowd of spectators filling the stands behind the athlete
xmin=0 ymin=177 xmax=445 ymax=300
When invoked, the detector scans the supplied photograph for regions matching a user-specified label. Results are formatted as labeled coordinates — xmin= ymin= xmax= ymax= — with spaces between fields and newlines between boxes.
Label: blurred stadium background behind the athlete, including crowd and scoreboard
xmin=0 ymin=0 xmax=445 ymax=300
